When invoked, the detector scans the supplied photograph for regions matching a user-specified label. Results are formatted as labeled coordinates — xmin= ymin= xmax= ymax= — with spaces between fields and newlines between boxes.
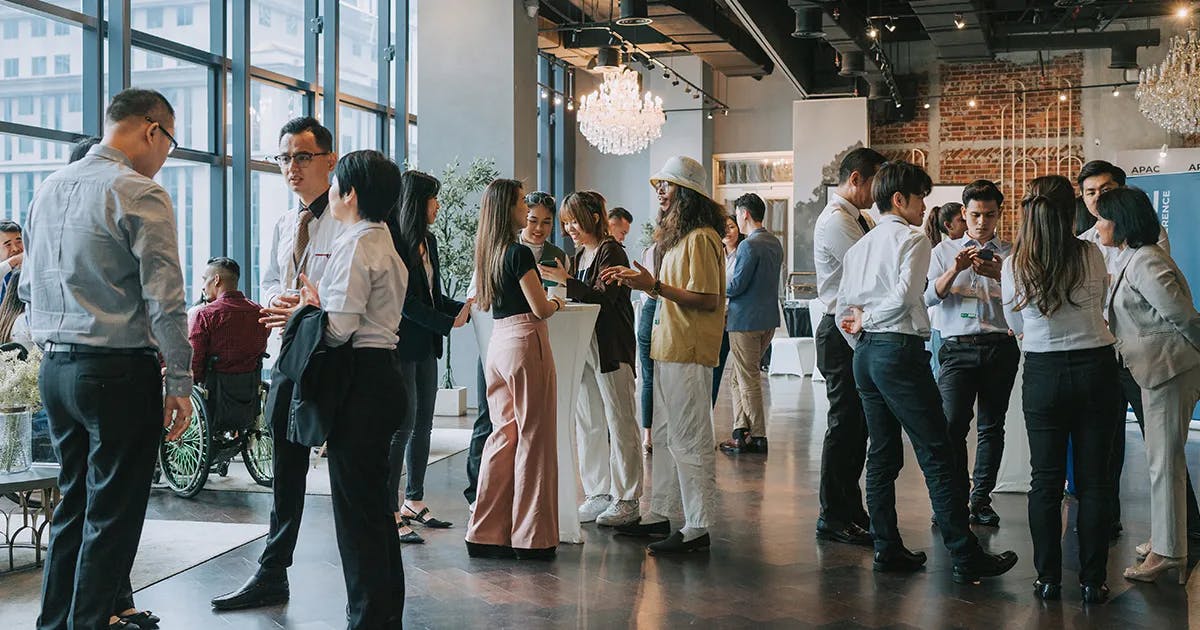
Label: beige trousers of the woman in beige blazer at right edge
xmin=1141 ymin=367 xmax=1200 ymax=558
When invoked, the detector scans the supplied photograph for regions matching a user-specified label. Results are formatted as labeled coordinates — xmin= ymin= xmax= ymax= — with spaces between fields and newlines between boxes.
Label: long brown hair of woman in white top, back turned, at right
xmin=1013 ymin=175 xmax=1088 ymax=317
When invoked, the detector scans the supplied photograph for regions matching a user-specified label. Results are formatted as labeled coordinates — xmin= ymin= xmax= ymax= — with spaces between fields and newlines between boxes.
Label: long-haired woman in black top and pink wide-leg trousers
xmin=467 ymin=179 xmax=563 ymax=559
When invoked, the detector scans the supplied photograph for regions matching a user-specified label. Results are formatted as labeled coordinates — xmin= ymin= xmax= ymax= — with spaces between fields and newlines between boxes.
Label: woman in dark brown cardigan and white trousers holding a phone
xmin=539 ymin=192 xmax=642 ymax=527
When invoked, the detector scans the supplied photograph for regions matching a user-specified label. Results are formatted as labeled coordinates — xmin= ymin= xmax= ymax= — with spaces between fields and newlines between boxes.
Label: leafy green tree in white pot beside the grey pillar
xmin=430 ymin=158 xmax=500 ymax=415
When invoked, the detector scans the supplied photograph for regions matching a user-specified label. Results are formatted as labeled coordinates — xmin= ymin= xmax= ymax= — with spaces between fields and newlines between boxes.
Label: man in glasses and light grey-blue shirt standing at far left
xmin=18 ymin=89 xmax=192 ymax=630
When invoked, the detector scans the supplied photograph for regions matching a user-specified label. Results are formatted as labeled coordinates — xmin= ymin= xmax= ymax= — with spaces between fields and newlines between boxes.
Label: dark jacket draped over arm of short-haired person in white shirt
xmin=273 ymin=305 xmax=354 ymax=446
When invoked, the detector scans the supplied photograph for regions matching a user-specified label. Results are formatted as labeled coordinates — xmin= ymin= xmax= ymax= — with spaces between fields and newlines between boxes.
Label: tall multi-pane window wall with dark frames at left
xmin=0 ymin=0 xmax=412 ymax=301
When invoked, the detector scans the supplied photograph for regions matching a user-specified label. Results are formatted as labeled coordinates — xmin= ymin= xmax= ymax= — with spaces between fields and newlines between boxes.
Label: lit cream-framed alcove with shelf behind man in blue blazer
xmin=713 ymin=151 xmax=796 ymax=298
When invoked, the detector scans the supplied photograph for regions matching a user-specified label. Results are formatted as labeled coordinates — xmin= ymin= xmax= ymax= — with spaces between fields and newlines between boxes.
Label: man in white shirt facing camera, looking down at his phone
xmin=925 ymin=180 xmax=1020 ymax=527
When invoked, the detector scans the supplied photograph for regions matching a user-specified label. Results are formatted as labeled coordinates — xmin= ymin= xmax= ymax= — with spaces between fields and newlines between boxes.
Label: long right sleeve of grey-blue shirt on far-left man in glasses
xmin=120 ymin=186 xmax=192 ymax=396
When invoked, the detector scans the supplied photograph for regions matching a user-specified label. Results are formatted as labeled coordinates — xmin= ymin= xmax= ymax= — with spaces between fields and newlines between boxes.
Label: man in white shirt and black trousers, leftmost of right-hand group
xmin=812 ymin=148 xmax=887 ymax=547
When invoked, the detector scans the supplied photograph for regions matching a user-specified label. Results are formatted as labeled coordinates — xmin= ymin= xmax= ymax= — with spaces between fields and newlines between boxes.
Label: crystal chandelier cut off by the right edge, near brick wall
xmin=1136 ymin=30 xmax=1200 ymax=133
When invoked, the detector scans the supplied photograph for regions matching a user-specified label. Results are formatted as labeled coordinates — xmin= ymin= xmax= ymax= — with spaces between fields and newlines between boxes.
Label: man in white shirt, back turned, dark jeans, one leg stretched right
xmin=838 ymin=162 xmax=1016 ymax=583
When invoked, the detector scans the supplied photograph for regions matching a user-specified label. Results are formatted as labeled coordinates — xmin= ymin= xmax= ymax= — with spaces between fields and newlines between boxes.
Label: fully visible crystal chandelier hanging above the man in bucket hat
xmin=578 ymin=66 xmax=667 ymax=155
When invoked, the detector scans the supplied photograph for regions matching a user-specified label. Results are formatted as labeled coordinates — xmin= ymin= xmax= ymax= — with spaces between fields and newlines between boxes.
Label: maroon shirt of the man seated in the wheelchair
xmin=187 ymin=290 xmax=270 ymax=383
